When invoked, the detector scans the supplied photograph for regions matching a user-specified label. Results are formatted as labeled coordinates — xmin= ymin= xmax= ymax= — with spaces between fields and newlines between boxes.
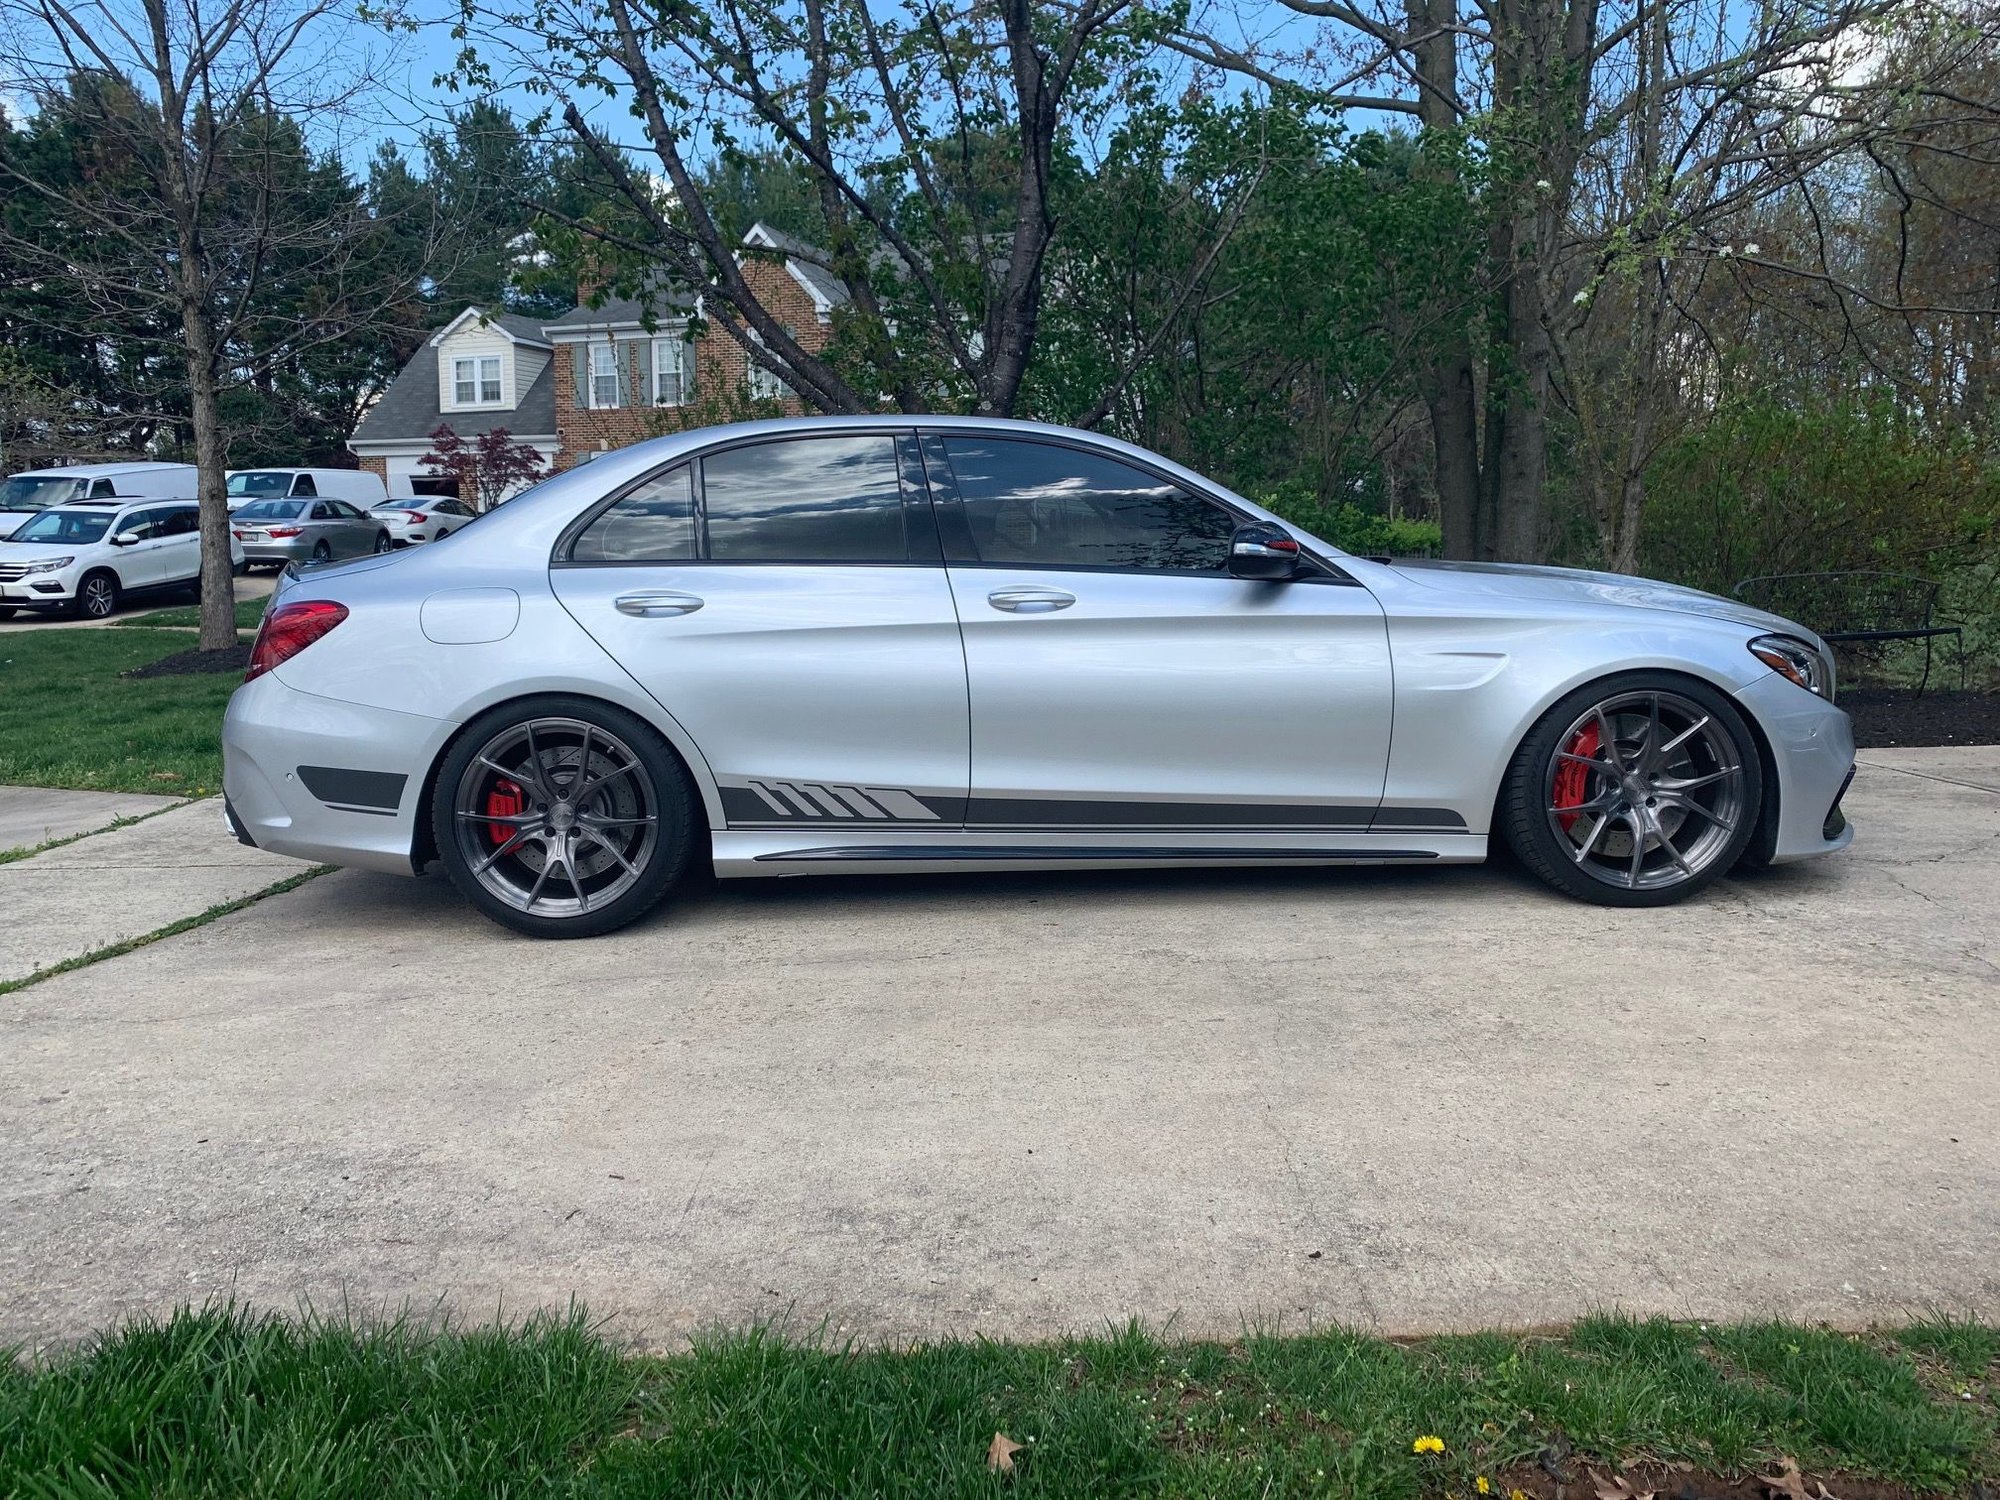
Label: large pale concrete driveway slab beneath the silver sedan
xmin=0 ymin=750 xmax=2000 ymax=1344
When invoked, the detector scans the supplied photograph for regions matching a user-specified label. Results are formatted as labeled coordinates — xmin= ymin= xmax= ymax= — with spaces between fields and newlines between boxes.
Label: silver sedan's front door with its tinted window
xmin=922 ymin=434 xmax=1392 ymax=846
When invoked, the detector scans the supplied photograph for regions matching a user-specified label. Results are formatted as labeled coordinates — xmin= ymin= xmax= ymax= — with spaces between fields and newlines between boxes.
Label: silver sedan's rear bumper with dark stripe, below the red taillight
xmin=222 ymin=672 xmax=458 ymax=874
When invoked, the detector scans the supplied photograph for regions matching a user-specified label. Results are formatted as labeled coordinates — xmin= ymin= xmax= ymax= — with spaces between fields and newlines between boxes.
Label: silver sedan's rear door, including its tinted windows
xmin=550 ymin=430 xmax=968 ymax=830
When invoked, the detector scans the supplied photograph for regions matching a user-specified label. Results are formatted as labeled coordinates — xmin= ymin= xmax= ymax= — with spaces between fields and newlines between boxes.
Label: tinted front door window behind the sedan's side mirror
xmin=944 ymin=438 xmax=1236 ymax=572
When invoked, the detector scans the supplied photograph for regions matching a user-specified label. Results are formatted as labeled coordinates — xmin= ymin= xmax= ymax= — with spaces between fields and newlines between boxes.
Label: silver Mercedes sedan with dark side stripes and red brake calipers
xmin=224 ymin=416 xmax=1854 ymax=936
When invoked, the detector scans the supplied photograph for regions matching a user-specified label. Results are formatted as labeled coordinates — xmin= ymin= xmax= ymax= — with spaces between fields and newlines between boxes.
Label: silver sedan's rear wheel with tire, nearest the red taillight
xmin=432 ymin=696 xmax=696 ymax=938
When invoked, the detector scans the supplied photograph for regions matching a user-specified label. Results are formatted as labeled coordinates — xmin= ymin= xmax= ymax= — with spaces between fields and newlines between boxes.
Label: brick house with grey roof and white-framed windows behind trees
xmin=348 ymin=224 xmax=848 ymax=496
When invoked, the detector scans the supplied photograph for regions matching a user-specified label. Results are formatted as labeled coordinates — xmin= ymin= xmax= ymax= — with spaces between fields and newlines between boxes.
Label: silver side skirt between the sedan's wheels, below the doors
xmin=712 ymin=824 xmax=1486 ymax=880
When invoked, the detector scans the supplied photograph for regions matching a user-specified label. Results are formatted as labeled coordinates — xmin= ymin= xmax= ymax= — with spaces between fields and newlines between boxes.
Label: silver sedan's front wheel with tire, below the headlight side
xmin=1498 ymin=672 xmax=1764 ymax=906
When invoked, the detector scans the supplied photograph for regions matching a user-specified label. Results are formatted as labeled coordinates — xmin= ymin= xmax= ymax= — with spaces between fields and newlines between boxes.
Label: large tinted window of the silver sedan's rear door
xmin=702 ymin=434 xmax=910 ymax=562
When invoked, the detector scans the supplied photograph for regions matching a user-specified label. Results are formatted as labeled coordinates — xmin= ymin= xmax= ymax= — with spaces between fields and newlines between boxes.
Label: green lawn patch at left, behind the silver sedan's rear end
xmin=0 ymin=626 xmax=242 ymax=796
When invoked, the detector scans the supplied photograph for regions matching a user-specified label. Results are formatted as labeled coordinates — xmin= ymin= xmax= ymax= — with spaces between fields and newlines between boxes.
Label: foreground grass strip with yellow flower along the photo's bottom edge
xmin=0 ymin=1310 xmax=2000 ymax=1500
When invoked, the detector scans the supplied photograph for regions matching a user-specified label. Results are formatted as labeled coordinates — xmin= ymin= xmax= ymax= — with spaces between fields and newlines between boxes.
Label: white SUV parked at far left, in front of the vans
xmin=0 ymin=500 xmax=242 ymax=620
